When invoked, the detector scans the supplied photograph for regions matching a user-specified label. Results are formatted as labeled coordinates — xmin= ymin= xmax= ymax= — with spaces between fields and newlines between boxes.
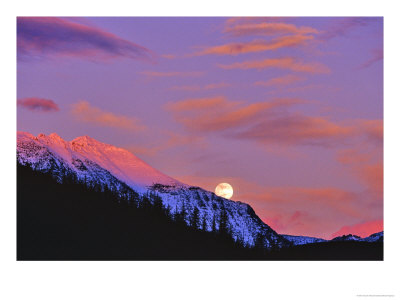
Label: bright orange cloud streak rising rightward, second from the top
xmin=194 ymin=35 xmax=313 ymax=55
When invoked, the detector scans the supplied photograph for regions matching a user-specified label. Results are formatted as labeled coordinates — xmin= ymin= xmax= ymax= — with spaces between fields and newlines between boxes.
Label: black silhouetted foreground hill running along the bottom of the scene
xmin=17 ymin=165 xmax=383 ymax=260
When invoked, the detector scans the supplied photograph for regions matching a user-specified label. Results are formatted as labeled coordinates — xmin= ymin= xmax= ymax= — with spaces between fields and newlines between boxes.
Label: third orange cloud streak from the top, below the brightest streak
xmin=218 ymin=57 xmax=330 ymax=74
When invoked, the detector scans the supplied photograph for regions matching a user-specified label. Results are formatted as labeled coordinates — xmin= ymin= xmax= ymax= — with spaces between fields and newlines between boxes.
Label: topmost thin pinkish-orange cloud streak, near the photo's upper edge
xmin=224 ymin=22 xmax=319 ymax=36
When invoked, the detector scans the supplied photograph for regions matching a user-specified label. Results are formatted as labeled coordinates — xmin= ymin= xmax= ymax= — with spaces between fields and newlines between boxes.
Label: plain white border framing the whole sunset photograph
xmin=0 ymin=0 xmax=400 ymax=300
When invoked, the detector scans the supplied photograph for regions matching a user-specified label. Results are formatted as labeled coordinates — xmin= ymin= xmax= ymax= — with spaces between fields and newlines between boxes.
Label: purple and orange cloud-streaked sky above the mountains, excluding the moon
xmin=17 ymin=17 xmax=383 ymax=238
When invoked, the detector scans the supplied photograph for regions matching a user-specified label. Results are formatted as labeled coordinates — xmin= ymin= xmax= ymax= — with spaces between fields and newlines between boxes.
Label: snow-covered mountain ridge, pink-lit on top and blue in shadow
xmin=17 ymin=132 xmax=290 ymax=248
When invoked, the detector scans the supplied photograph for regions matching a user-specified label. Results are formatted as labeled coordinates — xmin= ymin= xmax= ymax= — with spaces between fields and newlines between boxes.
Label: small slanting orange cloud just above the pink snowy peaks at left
xmin=71 ymin=101 xmax=146 ymax=131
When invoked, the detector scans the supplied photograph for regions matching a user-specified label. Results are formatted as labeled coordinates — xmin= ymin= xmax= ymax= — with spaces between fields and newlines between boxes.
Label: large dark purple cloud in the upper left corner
xmin=17 ymin=17 xmax=153 ymax=60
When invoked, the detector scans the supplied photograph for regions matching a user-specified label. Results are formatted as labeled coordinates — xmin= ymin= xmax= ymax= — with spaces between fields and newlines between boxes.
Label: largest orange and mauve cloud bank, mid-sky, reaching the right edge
xmin=165 ymin=96 xmax=383 ymax=147
